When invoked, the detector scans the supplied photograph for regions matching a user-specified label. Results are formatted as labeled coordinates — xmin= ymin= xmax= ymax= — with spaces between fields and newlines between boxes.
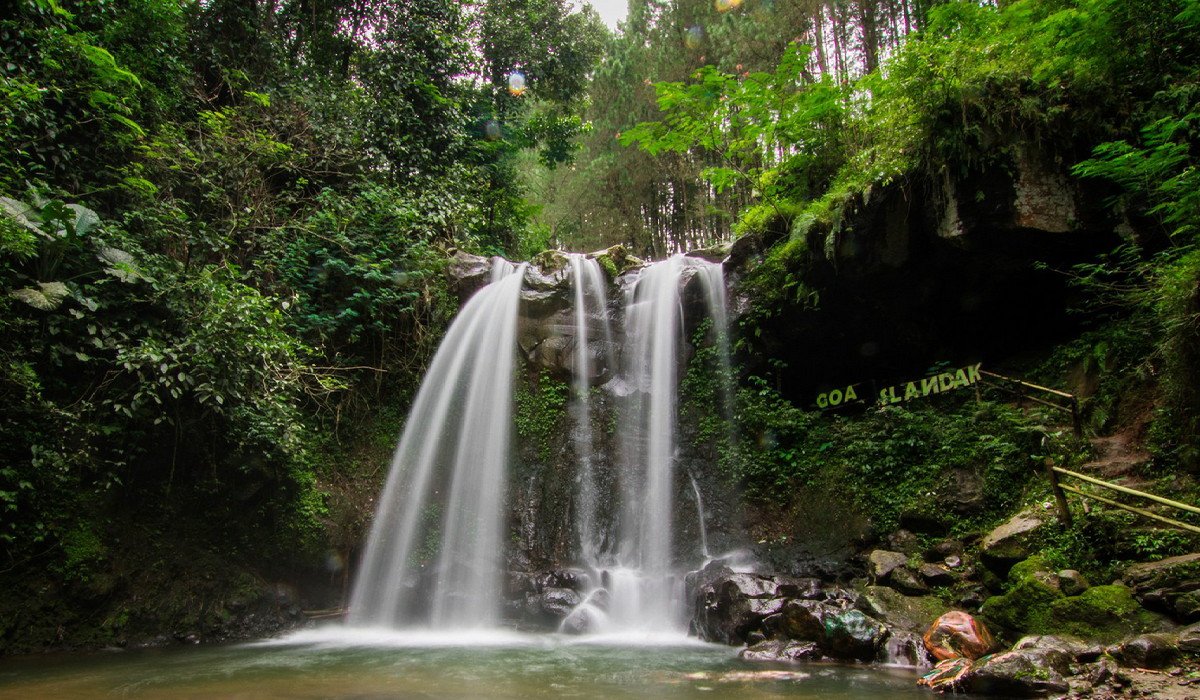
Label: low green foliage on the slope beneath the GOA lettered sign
xmin=683 ymin=333 xmax=1046 ymax=532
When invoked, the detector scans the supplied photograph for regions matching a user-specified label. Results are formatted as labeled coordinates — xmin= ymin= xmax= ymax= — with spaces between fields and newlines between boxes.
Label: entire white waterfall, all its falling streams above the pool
xmin=348 ymin=255 xmax=728 ymax=635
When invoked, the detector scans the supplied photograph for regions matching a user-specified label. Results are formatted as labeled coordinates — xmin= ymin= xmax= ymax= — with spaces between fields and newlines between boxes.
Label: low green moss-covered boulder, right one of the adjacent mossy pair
xmin=1050 ymin=585 xmax=1166 ymax=642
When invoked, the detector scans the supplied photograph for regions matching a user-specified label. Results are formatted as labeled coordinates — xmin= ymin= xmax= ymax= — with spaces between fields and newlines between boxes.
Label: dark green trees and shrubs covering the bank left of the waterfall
xmin=0 ymin=0 xmax=605 ymax=642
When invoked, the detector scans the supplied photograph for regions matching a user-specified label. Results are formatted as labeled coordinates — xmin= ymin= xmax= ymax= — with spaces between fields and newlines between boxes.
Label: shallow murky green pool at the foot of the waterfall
xmin=0 ymin=627 xmax=931 ymax=700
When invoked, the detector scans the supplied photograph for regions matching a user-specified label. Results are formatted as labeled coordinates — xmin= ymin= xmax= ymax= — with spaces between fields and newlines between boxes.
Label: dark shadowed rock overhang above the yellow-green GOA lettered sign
xmin=734 ymin=134 xmax=1120 ymax=410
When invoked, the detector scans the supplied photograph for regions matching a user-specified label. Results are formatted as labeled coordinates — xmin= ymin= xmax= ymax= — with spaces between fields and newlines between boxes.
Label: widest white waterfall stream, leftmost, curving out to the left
xmin=348 ymin=264 xmax=526 ymax=628
